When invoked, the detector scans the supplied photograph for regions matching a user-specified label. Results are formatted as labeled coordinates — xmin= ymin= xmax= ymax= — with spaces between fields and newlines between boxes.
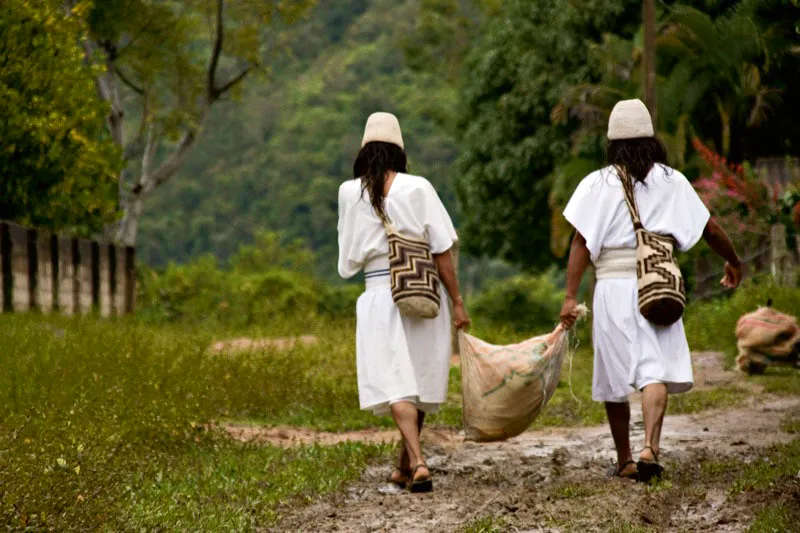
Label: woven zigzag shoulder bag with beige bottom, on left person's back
xmin=383 ymin=219 xmax=441 ymax=318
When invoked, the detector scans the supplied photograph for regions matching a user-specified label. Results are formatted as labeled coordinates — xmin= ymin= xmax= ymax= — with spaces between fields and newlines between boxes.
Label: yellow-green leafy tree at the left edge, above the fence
xmin=0 ymin=0 xmax=122 ymax=235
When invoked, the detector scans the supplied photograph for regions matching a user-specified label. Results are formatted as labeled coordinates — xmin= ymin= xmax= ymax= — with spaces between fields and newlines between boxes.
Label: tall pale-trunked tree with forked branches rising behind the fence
xmin=70 ymin=0 xmax=313 ymax=245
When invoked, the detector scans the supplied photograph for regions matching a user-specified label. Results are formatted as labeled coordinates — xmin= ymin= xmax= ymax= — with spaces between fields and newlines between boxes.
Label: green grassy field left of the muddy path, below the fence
xmin=0 ymin=315 xmax=389 ymax=530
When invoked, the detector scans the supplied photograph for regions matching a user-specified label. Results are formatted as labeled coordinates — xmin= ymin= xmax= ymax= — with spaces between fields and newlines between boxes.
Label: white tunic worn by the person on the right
xmin=564 ymin=165 xmax=710 ymax=402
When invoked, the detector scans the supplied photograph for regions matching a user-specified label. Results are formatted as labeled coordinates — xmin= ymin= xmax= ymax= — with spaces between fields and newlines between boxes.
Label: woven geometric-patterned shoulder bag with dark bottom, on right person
xmin=620 ymin=168 xmax=686 ymax=326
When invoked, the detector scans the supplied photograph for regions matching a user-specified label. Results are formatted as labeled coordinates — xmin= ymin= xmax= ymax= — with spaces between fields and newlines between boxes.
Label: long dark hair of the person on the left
xmin=353 ymin=141 xmax=408 ymax=219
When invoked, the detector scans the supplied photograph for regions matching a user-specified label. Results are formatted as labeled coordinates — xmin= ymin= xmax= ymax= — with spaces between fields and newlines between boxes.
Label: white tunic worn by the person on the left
xmin=338 ymin=174 xmax=458 ymax=415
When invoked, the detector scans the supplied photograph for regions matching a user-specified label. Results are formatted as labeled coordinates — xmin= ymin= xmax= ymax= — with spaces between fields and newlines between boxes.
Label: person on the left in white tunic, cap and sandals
xmin=338 ymin=113 xmax=470 ymax=492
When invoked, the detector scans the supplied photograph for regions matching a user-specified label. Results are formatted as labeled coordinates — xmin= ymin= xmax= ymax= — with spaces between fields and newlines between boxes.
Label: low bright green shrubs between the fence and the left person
xmin=137 ymin=233 xmax=362 ymax=329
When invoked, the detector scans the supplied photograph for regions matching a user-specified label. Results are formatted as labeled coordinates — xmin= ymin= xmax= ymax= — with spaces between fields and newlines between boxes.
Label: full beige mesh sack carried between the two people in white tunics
xmin=459 ymin=306 xmax=588 ymax=442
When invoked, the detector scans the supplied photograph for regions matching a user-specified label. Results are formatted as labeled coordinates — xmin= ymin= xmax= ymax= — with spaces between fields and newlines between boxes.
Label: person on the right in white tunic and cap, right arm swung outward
xmin=561 ymin=100 xmax=742 ymax=481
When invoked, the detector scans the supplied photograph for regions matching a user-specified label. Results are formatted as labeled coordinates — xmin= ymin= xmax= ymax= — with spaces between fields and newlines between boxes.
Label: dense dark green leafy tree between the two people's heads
xmin=456 ymin=0 xmax=641 ymax=269
